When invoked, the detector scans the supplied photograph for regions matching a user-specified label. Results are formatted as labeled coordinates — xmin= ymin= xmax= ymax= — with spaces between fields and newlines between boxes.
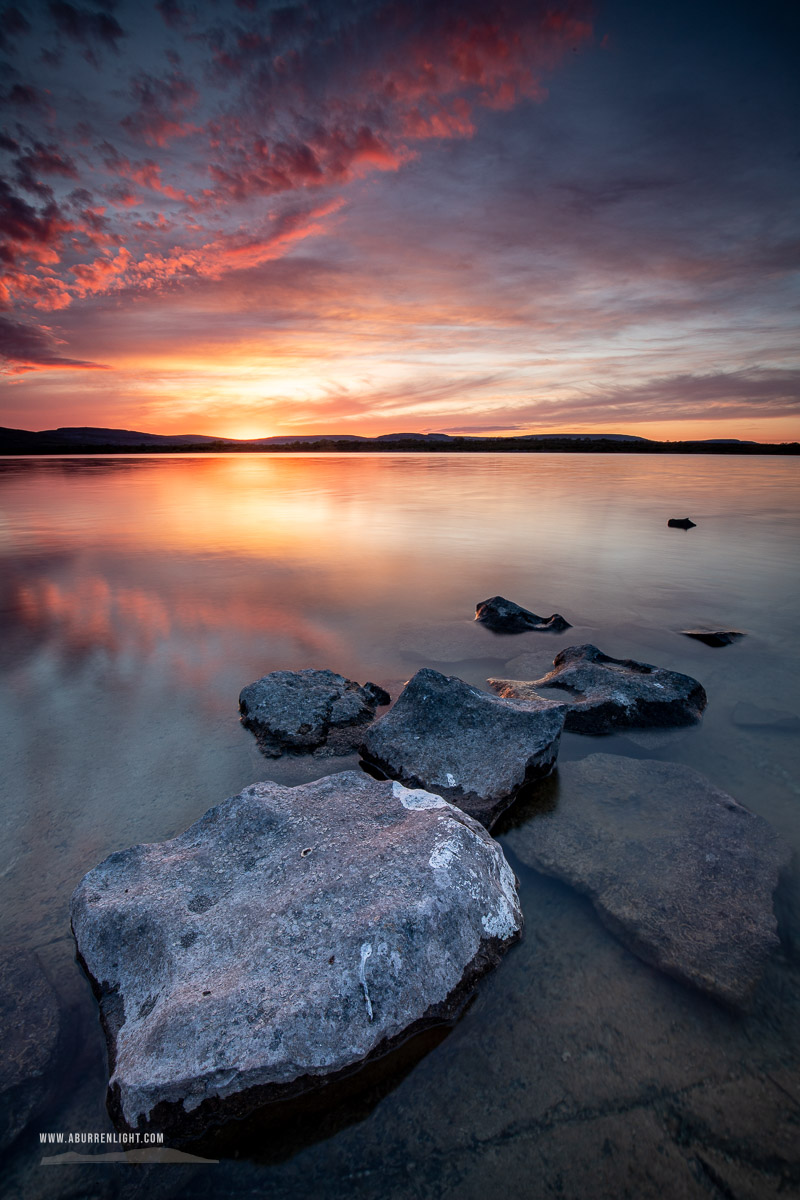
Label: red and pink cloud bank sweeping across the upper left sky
xmin=0 ymin=0 xmax=590 ymax=319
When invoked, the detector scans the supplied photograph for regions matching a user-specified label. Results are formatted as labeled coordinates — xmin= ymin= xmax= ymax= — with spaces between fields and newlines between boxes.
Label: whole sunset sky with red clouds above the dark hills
xmin=0 ymin=0 xmax=800 ymax=442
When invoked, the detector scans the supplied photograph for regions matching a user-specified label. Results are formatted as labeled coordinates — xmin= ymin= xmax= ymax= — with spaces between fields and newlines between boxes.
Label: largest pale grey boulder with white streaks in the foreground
xmin=72 ymin=772 xmax=522 ymax=1135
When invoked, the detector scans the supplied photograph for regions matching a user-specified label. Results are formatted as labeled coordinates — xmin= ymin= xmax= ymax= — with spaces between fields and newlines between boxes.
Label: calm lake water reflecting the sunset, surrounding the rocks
xmin=0 ymin=454 xmax=800 ymax=1200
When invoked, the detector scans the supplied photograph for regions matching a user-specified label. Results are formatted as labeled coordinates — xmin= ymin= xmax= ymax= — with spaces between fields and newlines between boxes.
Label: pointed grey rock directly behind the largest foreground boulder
xmin=361 ymin=667 xmax=564 ymax=828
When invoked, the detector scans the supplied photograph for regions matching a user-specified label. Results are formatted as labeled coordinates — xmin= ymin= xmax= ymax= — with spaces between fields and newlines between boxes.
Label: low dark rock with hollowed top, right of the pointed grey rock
xmin=488 ymin=646 xmax=708 ymax=733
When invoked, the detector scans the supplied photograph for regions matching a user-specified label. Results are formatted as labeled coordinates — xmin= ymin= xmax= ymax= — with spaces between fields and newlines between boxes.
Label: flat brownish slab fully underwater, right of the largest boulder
xmin=506 ymin=754 xmax=789 ymax=1006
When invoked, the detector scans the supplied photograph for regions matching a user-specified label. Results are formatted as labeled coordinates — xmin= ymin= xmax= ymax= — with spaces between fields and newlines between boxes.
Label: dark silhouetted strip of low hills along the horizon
xmin=0 ymin=426 xmax=800 ymax=455
